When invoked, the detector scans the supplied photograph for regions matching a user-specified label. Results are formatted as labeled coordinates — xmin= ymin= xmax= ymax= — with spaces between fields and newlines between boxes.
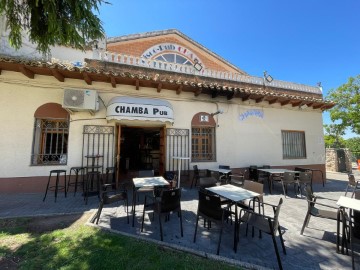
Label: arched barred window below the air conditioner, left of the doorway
xmin=31 ymin=103 xmax=69 ymax=165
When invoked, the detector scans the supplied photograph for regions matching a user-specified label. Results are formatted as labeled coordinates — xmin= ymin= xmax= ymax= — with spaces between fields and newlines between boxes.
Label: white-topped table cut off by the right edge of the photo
xmin=336 ymin=196 xmax=360 ymax=269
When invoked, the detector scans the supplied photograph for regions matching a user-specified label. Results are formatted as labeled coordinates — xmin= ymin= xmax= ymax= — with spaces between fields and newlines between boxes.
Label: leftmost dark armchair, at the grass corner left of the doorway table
xmin=90 ymin=180 xmax=129 ymax=224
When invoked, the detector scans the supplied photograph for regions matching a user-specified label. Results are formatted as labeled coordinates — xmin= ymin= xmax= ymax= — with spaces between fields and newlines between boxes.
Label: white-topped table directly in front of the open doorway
xmin=131 ymin=176 xmax=170 ymax=227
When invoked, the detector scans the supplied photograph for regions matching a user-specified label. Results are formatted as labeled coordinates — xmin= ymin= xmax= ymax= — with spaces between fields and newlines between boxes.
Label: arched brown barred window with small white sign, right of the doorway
xmin=191 ymin=113 xmax=216 ymax=162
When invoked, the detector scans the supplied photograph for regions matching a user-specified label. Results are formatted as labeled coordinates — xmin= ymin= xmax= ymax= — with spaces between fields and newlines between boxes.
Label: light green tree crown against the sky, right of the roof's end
xmin=328 ymin=75 xmax=360 ymax=134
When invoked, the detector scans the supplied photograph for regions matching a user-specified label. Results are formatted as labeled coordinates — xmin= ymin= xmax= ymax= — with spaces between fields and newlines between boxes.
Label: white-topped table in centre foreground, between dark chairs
xmin=205 ymin=184 xmax=260 ymax=252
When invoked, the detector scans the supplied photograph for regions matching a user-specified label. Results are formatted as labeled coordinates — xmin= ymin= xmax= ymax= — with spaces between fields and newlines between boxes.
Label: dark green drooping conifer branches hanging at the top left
xmin=0 ymin=0 xmax=108 ymax=53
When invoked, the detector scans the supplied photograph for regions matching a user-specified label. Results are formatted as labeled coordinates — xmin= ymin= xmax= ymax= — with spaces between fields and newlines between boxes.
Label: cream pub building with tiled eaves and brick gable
xmin=0 ymin=30 xmax=334 ymax=192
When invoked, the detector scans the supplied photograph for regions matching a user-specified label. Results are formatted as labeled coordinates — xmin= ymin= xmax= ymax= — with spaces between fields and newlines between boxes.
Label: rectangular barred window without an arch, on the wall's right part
xmin=281 ymin=130 xmax=306 ymax=159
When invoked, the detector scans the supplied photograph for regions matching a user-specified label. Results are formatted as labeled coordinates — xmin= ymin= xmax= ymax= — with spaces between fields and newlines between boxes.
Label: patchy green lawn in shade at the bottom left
xmin=0 ymin=214 xmax=242 ymax=270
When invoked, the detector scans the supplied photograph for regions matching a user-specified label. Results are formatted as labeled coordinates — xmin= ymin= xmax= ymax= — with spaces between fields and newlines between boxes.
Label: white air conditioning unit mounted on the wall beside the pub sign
xmin=63 ymin=89 xmax=99 ymax=112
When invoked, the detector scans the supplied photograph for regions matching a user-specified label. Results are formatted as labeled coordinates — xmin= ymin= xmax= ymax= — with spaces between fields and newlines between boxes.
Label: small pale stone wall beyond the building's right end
xmin=326 ymin=148 xmax=352 ymax=172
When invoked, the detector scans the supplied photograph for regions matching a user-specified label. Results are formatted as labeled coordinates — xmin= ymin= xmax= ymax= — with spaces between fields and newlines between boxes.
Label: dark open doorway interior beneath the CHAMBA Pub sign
xmin=120 ymin=127 xmax=160 ymax=174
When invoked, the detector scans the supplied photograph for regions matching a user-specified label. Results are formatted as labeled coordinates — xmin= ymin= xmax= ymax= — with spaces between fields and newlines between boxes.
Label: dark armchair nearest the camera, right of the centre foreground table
xmin=239 ymin=198 xmax=286 ymax=269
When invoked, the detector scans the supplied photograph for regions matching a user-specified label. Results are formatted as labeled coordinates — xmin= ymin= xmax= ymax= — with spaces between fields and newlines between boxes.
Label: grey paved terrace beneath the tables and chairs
xmin=0 ymin=172 xmax=360 ymax=269
